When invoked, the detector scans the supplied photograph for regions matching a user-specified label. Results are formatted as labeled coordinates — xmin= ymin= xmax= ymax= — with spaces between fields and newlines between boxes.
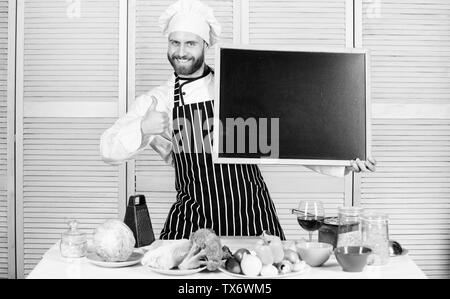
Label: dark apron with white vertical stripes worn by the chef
xmin=160 ymin=70 xmax=285 ymax=240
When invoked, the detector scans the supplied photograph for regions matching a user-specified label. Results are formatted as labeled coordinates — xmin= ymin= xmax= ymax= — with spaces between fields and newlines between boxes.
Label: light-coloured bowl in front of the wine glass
xmin=296 ymin=242 xmax=333 ymax=267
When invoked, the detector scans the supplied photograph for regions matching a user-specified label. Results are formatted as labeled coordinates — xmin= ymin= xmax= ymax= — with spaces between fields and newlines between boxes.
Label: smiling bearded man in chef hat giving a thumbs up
xmin=101 ymin=0 xmax=375 ymax=239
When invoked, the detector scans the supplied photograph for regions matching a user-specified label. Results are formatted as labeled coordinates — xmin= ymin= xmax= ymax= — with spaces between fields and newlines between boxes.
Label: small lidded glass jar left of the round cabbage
xmin=60 ymin=220 xmax=87 ymax=258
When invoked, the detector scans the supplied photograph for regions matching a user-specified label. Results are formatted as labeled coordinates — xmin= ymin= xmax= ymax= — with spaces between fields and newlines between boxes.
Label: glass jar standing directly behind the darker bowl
xmin=336 ymin=207 xmax=364 ymax=247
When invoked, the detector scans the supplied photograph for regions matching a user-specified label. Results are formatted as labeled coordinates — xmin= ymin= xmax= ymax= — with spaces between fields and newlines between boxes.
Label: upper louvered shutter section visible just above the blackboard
xmin=250 ymin=0 xmax=353 ymax=47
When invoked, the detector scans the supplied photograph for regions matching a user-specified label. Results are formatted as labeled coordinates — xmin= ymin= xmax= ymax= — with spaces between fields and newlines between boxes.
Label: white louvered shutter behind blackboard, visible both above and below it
xmin=248 ymin=0 xmax=353 ymax=239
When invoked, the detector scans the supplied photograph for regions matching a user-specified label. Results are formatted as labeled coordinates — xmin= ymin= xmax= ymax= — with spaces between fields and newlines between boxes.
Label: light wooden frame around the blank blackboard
xmin=212 ymin=44 xmax=372 ymax=166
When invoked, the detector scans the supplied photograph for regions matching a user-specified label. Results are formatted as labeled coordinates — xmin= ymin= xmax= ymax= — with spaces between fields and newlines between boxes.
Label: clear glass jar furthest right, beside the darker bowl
xmin=361 ymin=213 xmax=389 ymax=266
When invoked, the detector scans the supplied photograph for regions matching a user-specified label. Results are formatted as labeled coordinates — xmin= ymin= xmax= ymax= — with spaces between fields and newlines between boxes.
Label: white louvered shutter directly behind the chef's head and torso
xmin=130 ymin=0 xmax=233 ymax=236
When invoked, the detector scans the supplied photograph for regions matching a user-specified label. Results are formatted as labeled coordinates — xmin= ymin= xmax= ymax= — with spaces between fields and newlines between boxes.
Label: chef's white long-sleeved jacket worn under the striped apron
xmin=100 ymin=73 xmax=349 ymax=177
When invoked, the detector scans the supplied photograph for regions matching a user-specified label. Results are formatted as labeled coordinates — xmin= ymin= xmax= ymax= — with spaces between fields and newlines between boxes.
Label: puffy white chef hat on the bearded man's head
xmin=159 ymin=0 xmax=221 ymax=46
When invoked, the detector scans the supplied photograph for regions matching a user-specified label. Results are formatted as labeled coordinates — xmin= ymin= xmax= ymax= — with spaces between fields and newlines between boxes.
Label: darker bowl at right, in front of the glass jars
xmin=334 ymin=246 xmax=372 ymax=272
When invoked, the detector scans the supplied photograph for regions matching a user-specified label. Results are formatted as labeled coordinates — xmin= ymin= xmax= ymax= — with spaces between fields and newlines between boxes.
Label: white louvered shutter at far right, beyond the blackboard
xmin=360 ymin=0 xmax=450 ymax=278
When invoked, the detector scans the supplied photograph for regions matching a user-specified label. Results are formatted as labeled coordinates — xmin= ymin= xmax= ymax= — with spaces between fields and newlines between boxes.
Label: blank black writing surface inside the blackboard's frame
xmin=216 ymin=48 xmax=366 ymax=164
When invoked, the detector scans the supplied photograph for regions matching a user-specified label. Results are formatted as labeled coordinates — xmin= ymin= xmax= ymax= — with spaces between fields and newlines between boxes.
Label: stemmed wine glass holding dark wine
xmin=292 ymin=200 xmax=325 ymax=242
